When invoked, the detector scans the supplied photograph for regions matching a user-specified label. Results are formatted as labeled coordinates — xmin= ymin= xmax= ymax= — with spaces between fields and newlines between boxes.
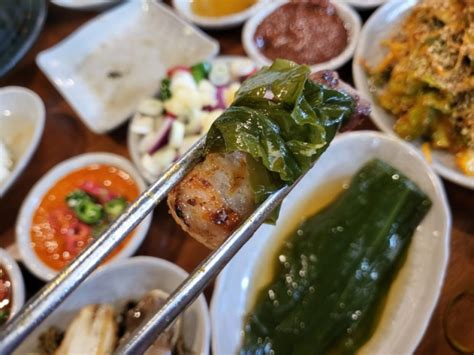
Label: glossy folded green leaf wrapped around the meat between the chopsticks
xmin=206 ymin=59 xmax=355 ymax=204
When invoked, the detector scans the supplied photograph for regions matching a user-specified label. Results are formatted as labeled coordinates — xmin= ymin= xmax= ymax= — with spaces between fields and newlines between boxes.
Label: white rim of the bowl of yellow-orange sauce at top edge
xmin=173 ymin=0 xmax=270 ymax=29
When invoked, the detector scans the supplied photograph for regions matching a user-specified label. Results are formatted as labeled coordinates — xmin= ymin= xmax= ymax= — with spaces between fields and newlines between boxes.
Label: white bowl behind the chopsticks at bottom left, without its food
xmin=15 ymin=256 xmax=211 ymax=355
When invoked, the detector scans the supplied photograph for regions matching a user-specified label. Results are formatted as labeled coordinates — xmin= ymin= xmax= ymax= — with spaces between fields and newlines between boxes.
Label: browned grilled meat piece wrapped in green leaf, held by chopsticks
xmin=168 ymin=60 xmax=369 ymax=248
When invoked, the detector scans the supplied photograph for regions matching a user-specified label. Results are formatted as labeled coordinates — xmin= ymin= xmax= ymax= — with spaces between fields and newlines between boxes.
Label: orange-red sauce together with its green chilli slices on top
xmin=30 ymin=164 xmax=139 ymax=270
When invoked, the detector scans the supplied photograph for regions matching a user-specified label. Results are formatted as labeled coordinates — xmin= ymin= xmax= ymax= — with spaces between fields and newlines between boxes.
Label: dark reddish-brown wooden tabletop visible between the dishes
xmin=0 ymin=5 xmax=474 ymax=354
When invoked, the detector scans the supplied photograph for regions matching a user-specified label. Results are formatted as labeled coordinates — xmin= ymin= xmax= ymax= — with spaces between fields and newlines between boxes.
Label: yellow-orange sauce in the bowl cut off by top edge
xmin=191 ymin=0 xmax=257 ymax=17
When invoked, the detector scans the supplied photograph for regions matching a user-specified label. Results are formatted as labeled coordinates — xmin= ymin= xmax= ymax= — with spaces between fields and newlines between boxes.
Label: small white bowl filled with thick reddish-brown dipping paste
xmin=242 ymin=0 xmax=361 ymax=71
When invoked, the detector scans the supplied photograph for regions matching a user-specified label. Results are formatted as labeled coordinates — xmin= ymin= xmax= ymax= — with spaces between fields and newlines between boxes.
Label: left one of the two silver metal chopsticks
xmin=0 ymin=137 xmax=205 ymax=354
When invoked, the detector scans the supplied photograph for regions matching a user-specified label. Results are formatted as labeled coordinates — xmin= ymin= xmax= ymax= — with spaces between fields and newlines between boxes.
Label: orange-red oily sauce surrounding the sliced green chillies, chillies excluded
xmin=30 ymin=164 xmax=139 ymax=270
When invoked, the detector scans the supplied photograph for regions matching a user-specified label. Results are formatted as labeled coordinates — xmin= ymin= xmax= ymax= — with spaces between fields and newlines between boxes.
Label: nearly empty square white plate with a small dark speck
xmin=36 ymin=0 xmax=219 ymax=133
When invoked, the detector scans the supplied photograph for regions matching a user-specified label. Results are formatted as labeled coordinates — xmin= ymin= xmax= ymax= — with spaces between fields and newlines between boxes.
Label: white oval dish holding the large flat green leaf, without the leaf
xmin=211 ymin=131 xmax=451 ymax=354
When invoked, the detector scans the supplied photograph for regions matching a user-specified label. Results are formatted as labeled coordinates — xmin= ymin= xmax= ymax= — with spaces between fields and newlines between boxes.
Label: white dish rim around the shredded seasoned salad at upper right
xmin=352 ymin=0 xmax=474 ymax=189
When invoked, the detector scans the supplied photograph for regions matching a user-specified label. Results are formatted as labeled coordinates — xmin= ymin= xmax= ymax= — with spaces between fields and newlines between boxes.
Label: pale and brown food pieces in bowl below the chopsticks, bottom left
xmin=39 ymin=289 xmax=186 ymax=355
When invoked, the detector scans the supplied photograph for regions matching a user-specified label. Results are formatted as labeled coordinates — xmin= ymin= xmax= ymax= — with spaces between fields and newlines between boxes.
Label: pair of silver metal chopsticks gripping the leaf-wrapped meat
xmin=0 ymin=134 xmax=304 ymax=354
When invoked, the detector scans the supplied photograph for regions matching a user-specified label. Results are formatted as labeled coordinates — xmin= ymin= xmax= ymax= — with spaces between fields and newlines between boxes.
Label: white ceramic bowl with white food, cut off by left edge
xmin=0 ymin=86 xmax=45 ymax=198
